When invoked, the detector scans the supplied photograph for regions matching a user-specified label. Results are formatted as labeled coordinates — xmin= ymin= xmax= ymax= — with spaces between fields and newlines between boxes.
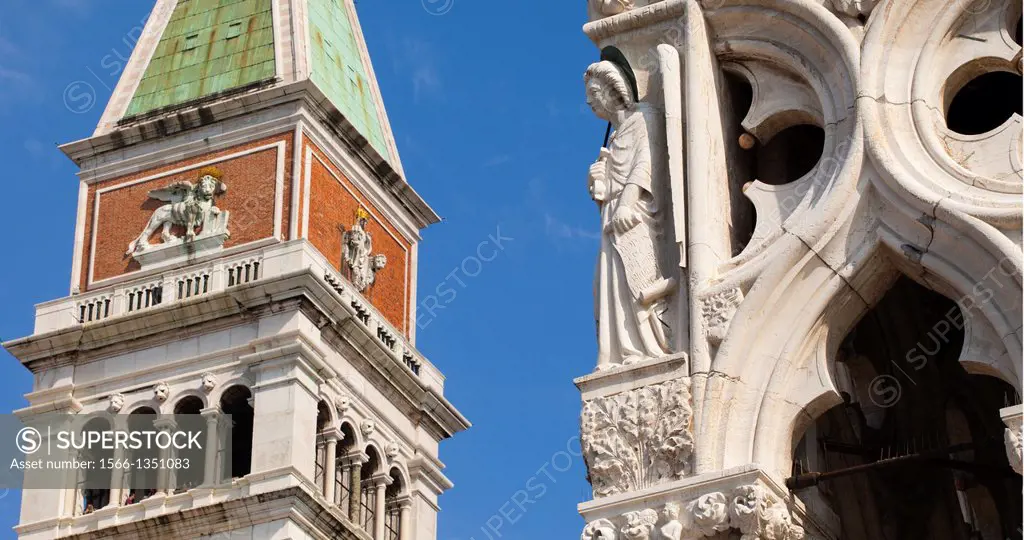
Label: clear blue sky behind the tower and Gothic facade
xmin=0 ymin=0 xmax=604 ymax=540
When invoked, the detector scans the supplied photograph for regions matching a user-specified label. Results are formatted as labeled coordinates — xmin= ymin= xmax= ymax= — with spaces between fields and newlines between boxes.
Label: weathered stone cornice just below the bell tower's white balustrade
xmin=3 ymin=269 xmax=470 ymax=439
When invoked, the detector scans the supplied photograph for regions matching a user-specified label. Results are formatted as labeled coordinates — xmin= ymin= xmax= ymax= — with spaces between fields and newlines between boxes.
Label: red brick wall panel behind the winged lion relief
xmin=81 ymin=133 xmax=294 ymax=291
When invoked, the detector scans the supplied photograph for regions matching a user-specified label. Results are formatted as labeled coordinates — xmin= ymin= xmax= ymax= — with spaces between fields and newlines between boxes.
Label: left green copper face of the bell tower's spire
xmin=125 ymin=0 xmax=275 ymax=116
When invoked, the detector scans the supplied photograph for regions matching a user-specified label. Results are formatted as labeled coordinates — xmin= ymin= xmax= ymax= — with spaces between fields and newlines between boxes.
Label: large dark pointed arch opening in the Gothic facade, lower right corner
xmin=786 ymin=278 xmax=1021 ymax=540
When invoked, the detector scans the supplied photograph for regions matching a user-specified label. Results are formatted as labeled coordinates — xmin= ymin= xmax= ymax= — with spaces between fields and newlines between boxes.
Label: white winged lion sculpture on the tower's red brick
xmin=126 ymin=167 xmax=227 ymax=256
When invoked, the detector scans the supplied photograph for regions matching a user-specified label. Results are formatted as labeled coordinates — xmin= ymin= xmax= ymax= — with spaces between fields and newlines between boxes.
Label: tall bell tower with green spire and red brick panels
xmin=3 ymin=0 xmax=469 ymax=540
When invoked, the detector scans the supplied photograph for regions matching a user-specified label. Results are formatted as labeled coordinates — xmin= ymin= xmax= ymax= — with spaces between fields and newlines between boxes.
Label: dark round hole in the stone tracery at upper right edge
xmin=946 ymin=68 xmax=1024 ymax=135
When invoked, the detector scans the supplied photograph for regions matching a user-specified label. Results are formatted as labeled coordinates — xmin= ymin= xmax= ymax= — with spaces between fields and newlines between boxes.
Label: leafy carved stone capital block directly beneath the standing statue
xmin=581 ymin=377 xmax=693 ymax=497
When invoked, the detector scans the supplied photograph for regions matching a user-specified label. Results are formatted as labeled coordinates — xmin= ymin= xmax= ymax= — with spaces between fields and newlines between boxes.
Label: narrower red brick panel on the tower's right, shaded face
xmin=303 ymin=139 xmax=413 ymax=334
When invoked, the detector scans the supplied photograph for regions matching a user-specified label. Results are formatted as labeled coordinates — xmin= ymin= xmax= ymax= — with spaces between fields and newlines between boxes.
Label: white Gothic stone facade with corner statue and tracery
xmin=575 ymin=0 xmax=1024 ymax=540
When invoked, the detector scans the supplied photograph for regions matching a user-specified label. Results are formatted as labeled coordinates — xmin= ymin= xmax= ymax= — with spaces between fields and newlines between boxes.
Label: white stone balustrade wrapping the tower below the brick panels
xmin=35 ymin=241 xmax=443 ymax=389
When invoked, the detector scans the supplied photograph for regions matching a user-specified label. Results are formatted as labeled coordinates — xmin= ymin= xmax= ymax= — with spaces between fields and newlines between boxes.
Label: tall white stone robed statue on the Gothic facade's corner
xmin=584 ymin=53 xmax=676 ymax=371
